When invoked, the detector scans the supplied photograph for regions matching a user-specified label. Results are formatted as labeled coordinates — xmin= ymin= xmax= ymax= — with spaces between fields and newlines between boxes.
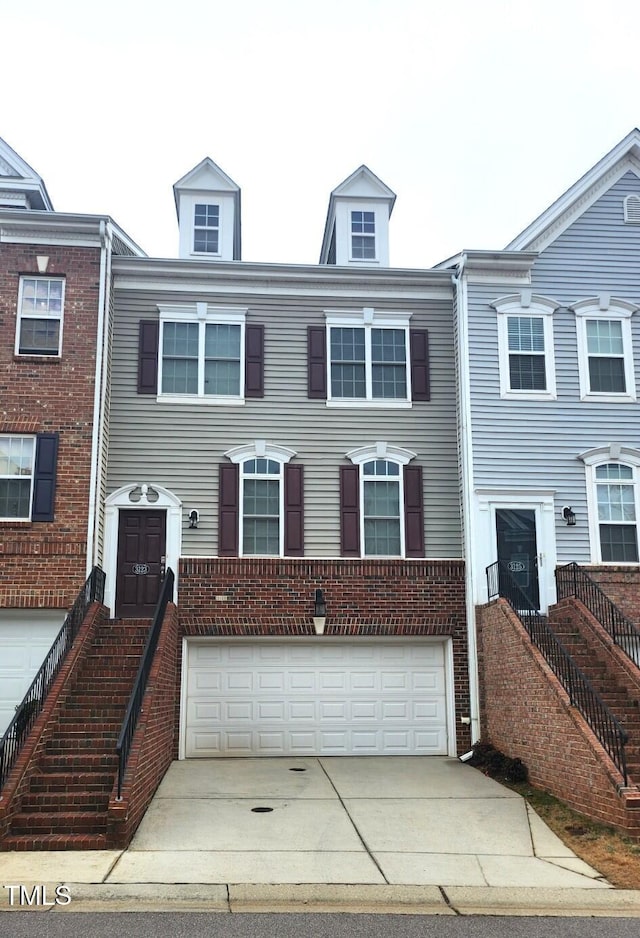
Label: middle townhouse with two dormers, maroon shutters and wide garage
xmin=104 ymin=159 xmax=471 ymax=756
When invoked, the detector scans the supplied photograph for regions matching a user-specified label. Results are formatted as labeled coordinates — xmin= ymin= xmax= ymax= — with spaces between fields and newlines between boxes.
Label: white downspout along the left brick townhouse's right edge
xmin=86 ymin=218 xmax=111 ymax=576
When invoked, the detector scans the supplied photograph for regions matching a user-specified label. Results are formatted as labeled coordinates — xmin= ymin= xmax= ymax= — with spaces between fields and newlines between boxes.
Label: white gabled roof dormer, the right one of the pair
xmin=320 ymin=166 xmax=396 ymax=267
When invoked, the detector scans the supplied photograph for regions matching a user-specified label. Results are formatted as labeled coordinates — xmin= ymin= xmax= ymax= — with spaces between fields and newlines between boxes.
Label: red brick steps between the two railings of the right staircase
xmin=550 ymin=607 xmax=640 ymax=784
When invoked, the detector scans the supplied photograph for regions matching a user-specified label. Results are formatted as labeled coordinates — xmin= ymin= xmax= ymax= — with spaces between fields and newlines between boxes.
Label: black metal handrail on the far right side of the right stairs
xmin=556 ymin=563 xmax=640 ymax=667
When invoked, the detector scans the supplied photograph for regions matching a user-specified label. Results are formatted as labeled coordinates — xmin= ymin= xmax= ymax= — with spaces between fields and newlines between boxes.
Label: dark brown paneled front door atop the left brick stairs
xmin=116 ymin=509 xmax=166 ymax=619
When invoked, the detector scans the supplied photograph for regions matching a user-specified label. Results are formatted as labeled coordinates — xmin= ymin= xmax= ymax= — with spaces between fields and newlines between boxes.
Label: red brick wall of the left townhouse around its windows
xmin=0 ymin=244 xmax=100 ymax=608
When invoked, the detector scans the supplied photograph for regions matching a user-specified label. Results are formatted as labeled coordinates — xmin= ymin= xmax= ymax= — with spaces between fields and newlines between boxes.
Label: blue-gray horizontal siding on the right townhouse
xmin=469 ymin=173 xmax=640 ymax=563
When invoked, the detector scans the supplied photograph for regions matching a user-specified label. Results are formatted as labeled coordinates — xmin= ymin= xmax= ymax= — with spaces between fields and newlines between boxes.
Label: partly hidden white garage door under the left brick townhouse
xmin=0 ymin=609 xmax=65 ymax=736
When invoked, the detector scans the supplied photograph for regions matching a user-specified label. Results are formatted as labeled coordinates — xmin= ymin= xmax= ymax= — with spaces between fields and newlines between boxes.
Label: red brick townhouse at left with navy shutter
xmin=0 ymin=140 xmax=141 ymax=733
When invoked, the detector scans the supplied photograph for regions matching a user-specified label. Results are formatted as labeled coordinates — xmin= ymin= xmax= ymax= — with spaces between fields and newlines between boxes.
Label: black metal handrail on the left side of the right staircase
xmin=486 ymin=561 xmax=629 ymax=786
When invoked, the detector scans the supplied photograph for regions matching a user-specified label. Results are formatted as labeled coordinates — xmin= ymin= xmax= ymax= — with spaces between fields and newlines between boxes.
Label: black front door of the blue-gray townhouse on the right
xmin=496 ymin=508 xmax=540 ymax=609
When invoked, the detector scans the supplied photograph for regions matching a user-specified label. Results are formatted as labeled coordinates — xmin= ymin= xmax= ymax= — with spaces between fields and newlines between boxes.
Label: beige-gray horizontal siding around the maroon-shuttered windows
xmin=107 ymin=282 xmax=461 ymax=558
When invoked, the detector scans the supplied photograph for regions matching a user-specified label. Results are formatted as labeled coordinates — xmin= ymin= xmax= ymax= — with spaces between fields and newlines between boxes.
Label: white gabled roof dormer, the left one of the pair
xmin=173 ymin=156 xmax=240 ymax=261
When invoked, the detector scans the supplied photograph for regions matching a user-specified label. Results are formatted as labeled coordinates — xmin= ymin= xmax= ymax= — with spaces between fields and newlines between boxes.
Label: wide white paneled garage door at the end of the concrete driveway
xmin=183 ymin=638 xmax=447 ymax=757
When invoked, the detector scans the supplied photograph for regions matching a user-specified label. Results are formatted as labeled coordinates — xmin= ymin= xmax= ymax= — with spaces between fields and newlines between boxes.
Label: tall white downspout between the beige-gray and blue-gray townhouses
xmin=451 ymin=254 xmax=480 ymax=745
